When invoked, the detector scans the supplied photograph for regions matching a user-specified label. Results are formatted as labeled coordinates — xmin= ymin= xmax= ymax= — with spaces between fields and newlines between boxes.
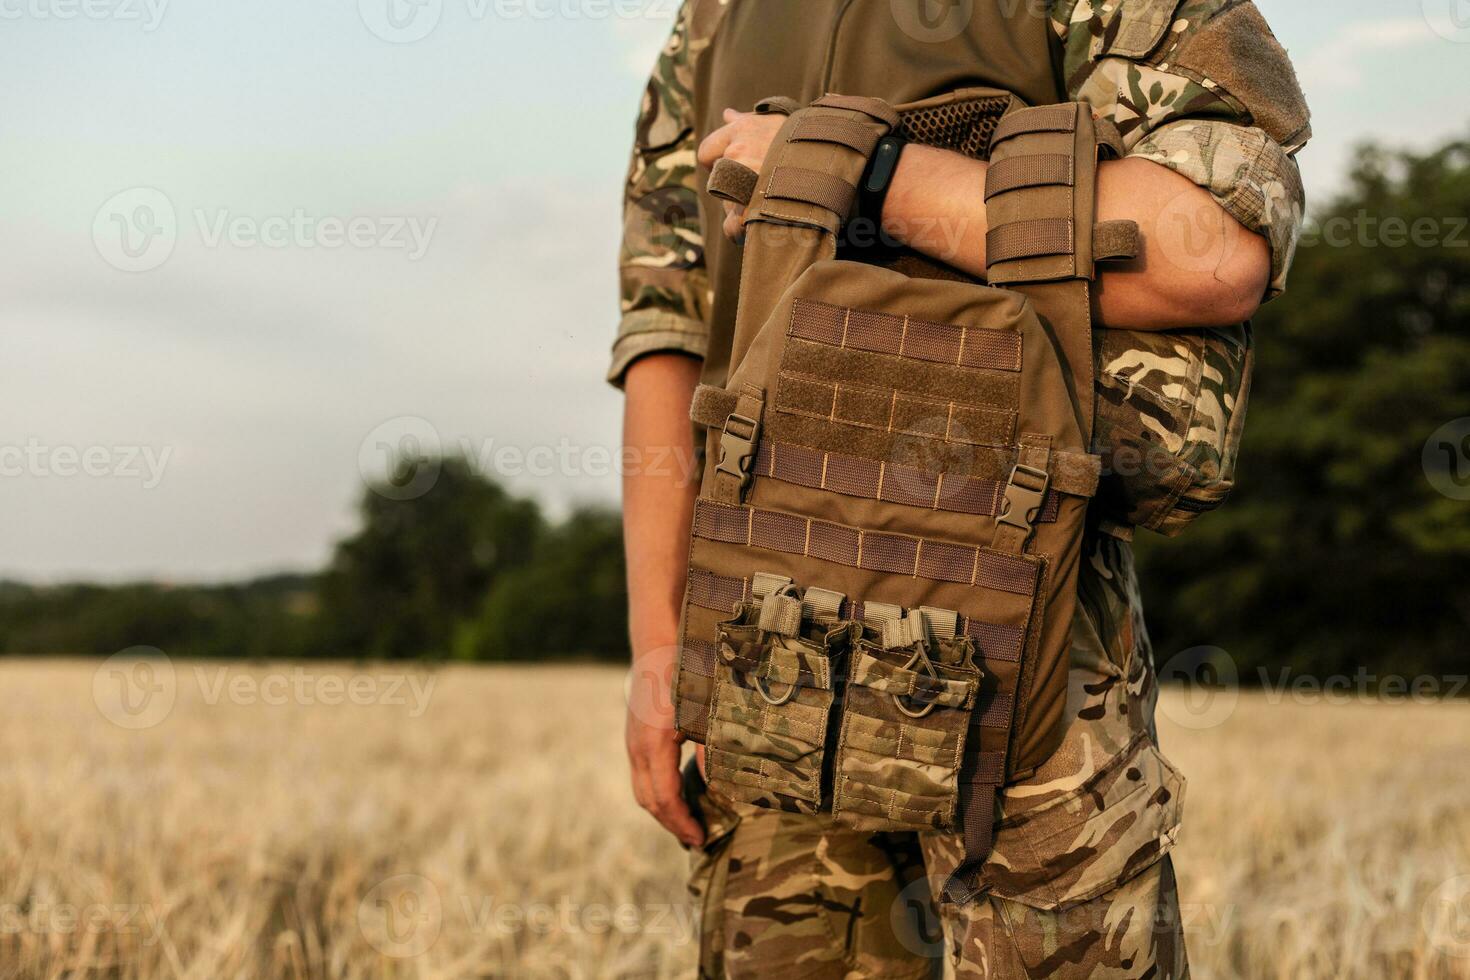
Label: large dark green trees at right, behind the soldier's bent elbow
xmin=1139 ymin=134 xmax=1470 ymax=676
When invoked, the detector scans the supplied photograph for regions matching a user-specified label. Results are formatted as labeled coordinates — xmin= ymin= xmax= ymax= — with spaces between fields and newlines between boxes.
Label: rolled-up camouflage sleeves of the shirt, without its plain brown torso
xmin=609 ymin=0 xmax=1310 ymax=385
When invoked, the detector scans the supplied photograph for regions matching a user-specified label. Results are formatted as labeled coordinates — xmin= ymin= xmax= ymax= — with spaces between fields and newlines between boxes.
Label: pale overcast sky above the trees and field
xmin=0 ymin=0 xmax=1470 ymax=580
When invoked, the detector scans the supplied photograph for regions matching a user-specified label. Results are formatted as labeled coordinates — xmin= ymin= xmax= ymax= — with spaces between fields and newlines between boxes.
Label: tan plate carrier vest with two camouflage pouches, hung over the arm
xmin=675 ymin=90 xmax=1138 ymax=901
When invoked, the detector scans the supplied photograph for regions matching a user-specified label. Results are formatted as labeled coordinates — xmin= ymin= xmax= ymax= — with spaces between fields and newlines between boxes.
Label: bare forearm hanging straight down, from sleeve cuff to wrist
xmin=623 ymin=354 xmax=700 ymax=654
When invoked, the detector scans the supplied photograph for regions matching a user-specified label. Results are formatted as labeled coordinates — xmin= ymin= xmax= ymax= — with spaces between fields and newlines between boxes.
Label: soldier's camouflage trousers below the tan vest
xmin=691 ymin=630 xmax=1188 ymax=980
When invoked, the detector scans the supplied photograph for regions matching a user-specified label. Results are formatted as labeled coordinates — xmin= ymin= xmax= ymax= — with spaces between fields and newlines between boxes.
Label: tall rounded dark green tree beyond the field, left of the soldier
xmin=318 ymin=457 xmax=544 ymax=658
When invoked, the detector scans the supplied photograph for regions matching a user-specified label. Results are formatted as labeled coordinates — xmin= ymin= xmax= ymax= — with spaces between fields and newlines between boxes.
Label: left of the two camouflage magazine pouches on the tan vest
xmin=706 ymin=599 xmax=848 ymax=813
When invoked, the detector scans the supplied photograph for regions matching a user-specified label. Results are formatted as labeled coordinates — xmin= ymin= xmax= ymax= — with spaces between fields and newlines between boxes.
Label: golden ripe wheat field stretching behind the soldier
xmin=0 ymin=660 xmax=1470 ymax=980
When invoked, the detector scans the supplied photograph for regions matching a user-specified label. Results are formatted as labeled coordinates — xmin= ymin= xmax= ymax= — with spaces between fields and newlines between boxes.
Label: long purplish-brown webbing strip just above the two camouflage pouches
xmin=694 ymin=500 xmax=1036 ymax=595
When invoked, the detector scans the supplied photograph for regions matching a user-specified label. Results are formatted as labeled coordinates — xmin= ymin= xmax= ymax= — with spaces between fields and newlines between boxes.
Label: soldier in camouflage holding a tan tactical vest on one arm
xmin=609 ymin=0 xmax=1310 ymax=977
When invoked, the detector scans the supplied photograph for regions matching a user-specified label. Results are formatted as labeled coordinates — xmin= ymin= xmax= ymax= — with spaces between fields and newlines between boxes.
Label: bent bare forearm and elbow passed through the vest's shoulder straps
xmin=883 ymin=145 xmax=1270 ymax=329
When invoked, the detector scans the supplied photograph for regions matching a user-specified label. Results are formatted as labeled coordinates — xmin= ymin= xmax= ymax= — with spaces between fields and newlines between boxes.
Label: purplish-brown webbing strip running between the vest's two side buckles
xmin=753 ymin=439 xmax=1061 ymax=523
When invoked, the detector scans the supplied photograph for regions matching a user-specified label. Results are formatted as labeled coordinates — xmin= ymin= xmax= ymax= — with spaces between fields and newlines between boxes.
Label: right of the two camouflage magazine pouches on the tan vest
xmin=832 ymin=614 xmax=980 ymax=832
